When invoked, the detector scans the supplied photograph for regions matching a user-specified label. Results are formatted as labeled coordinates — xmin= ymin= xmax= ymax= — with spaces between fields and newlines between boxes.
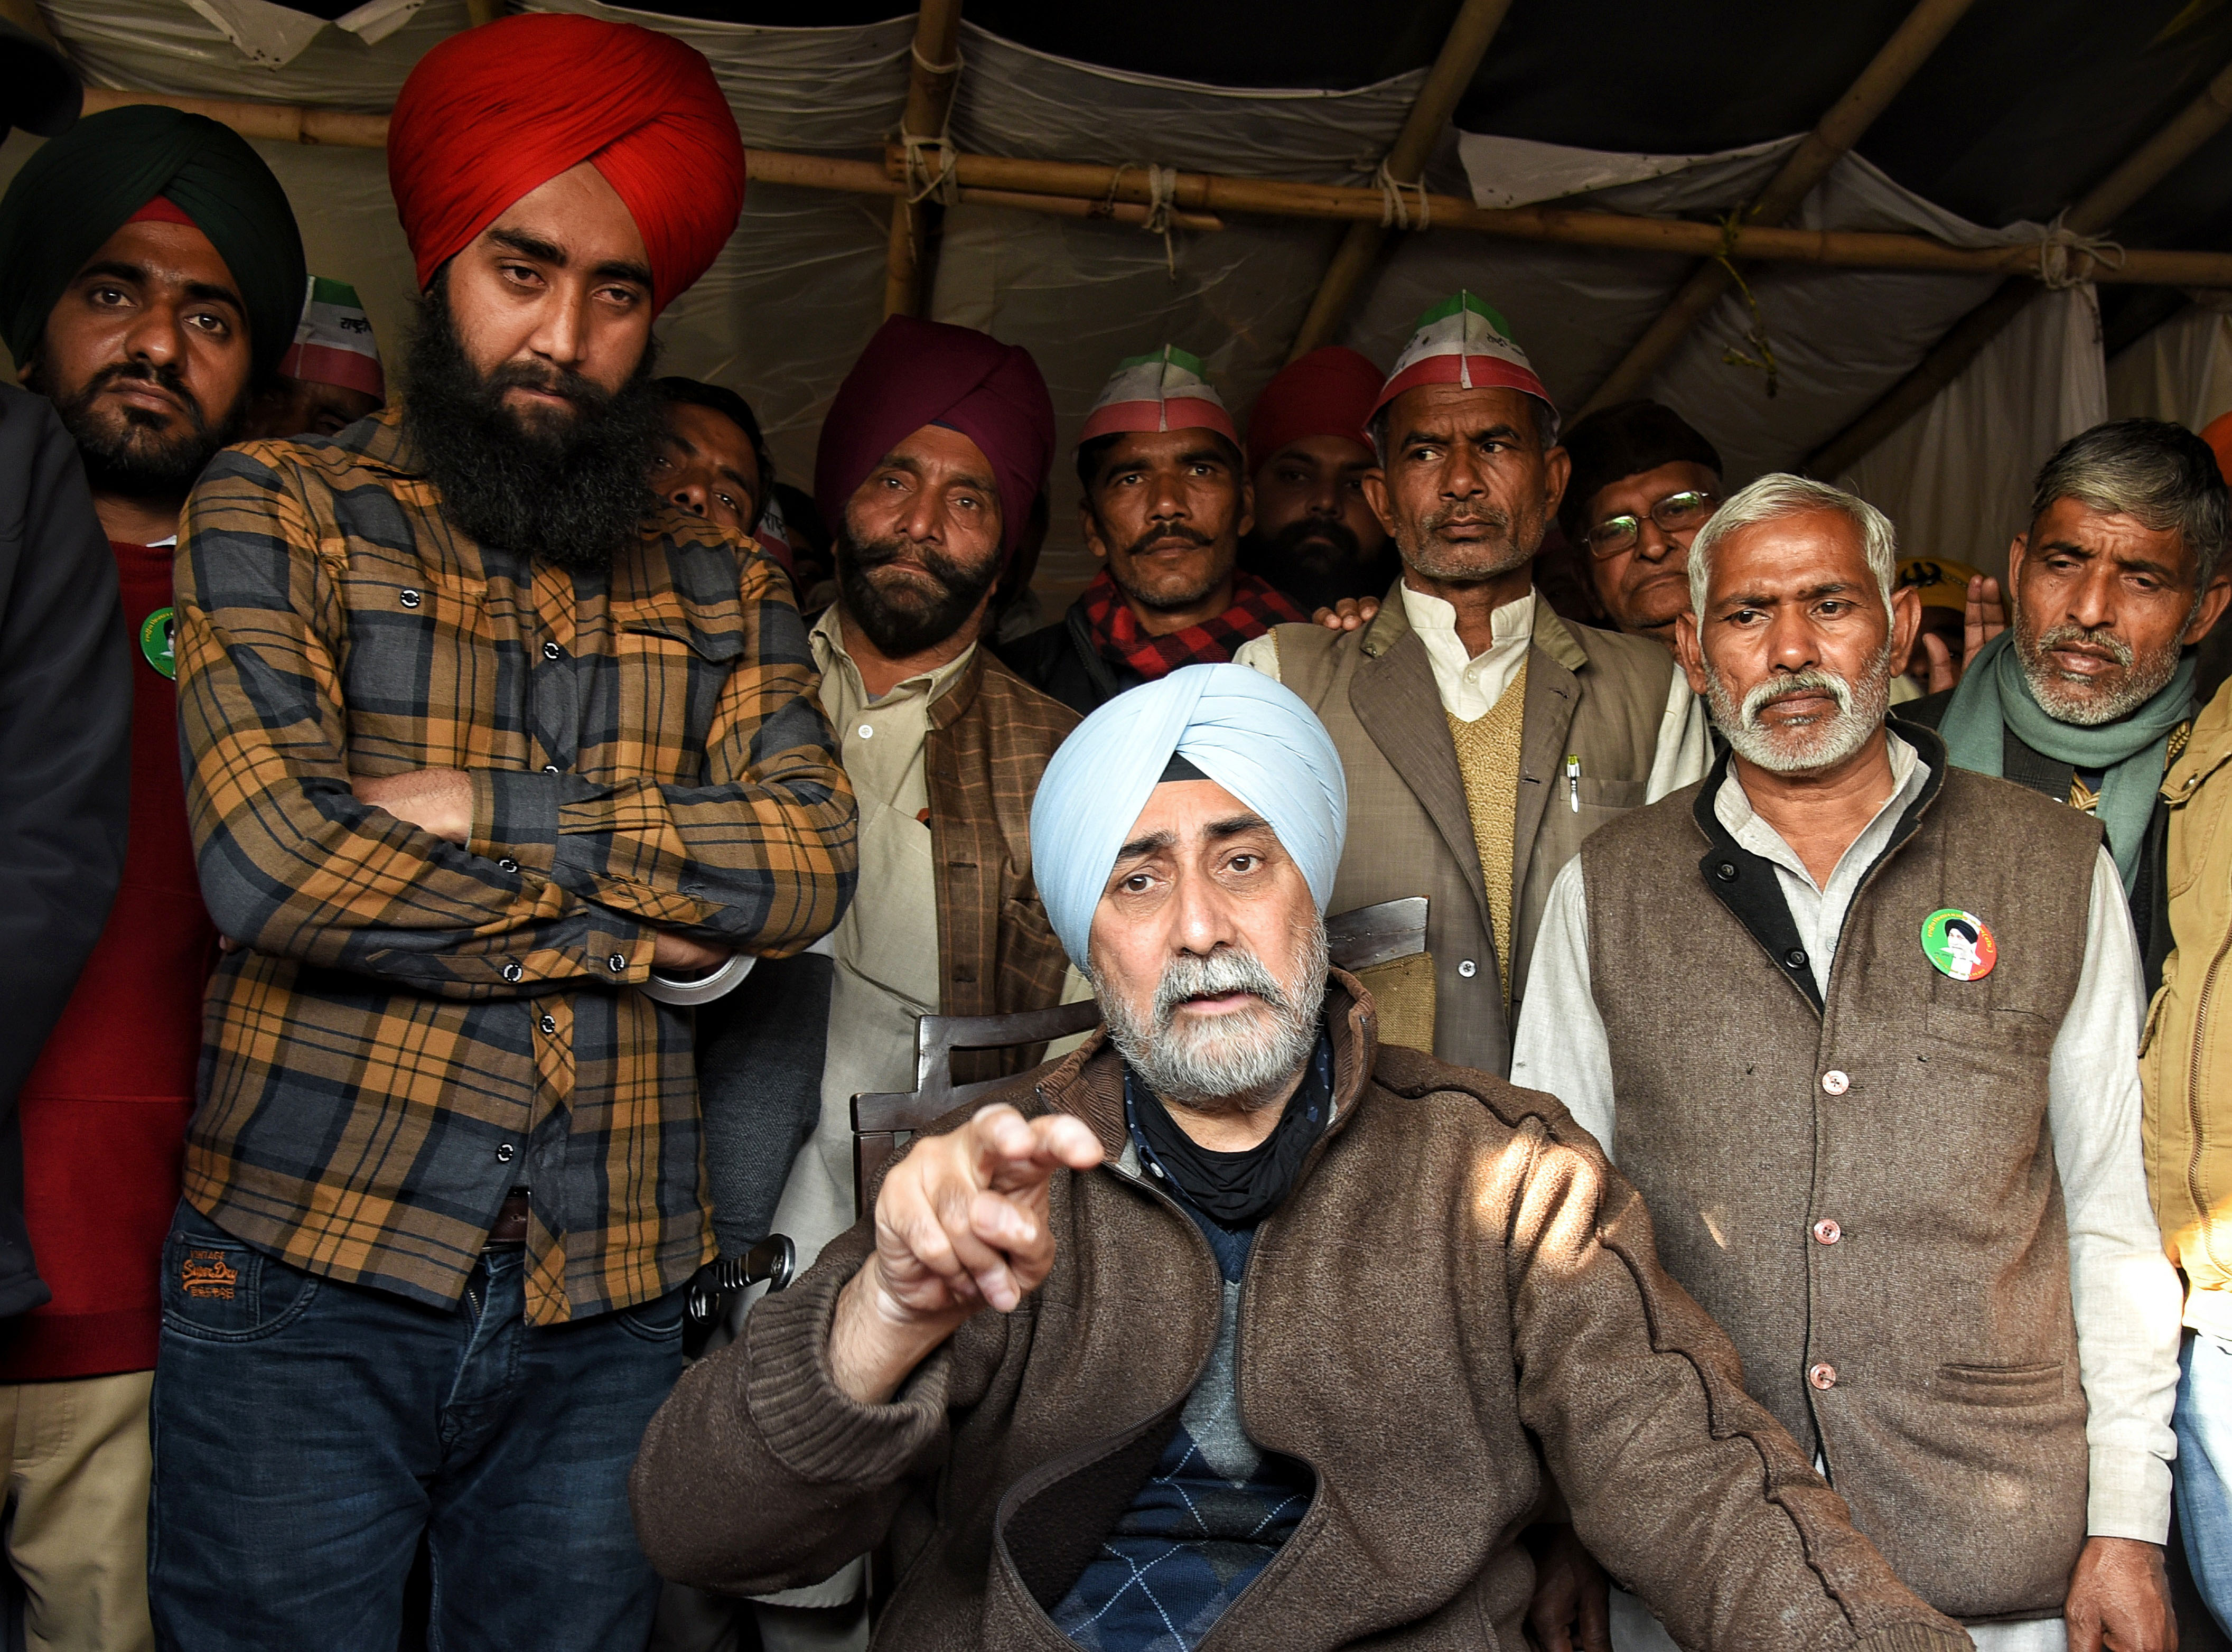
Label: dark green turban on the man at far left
xmin=0 ymin=102 xmax=308 ymax=379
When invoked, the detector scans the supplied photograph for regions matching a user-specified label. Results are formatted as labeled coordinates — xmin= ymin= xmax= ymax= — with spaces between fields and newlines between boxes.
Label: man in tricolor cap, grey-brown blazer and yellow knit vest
xmin=1239 ymin=293 xmax=1710 ymax=1074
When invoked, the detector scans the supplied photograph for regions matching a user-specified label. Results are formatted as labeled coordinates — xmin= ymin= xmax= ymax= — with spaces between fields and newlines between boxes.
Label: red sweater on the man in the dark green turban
xmin=0 ymin=545 xmax=217 ymax=1382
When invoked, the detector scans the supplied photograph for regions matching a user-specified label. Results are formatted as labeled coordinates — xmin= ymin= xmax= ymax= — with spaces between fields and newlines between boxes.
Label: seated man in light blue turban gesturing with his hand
xmin=634 ymin=665 xmax=1966 ymax=1652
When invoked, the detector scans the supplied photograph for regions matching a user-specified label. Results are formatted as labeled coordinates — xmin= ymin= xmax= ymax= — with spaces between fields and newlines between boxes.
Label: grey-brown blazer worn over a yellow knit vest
xmin=1272 ymin=596 xmax=1694 ymax=1076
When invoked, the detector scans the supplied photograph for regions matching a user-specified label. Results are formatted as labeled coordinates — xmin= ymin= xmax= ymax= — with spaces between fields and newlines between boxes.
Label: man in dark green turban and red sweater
xmin=0 ymin=107 xmax=304 ymax=1648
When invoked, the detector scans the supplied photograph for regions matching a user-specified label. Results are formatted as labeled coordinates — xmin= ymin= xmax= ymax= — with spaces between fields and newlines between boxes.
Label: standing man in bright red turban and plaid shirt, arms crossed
xmin=150 ymin=13 xmax=855 ymax=1652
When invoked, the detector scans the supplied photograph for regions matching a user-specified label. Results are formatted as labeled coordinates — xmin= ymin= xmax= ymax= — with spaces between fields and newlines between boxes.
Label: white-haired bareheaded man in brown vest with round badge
xmin=1514 ymin=475 xmax=2179 ymax=1652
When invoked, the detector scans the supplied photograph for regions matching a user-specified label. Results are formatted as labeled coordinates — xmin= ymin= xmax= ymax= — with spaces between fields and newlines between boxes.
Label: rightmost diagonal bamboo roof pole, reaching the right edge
xmin=1806 ymin=51 xmax=2232 ymax=475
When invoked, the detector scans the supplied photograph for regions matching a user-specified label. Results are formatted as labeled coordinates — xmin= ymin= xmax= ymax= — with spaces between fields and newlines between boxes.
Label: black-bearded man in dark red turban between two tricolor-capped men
xmin=1241 ymin=344 xmax=1402 ymax=612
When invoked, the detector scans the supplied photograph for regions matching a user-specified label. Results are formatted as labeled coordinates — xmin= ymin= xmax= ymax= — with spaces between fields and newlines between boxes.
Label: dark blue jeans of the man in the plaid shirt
xmin=147 ymin=1206 xmax=683 ymax=1652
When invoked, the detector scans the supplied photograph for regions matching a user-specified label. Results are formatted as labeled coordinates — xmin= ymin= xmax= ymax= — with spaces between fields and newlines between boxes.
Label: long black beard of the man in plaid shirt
xmin=404 ymin=275 xmax=667 ymax=572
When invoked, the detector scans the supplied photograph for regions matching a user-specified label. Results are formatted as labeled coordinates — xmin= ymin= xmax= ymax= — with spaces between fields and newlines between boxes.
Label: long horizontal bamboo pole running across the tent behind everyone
xmin=61 ymin=87 xmax=2232 ymax=288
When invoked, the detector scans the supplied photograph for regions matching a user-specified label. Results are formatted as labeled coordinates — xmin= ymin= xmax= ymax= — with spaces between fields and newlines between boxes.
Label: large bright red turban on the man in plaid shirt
xmin=388 ymin=11 xmax=743 ymax=310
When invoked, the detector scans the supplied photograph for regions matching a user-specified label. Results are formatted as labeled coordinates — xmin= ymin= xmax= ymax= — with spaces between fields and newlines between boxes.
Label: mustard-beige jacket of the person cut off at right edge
xmin=2141 ymin=683 xmax=2232 ymax=1337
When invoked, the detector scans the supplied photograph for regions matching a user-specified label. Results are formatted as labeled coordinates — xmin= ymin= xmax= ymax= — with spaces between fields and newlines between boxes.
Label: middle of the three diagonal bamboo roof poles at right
xmin=1580 ymin=0 xmax=1973 ymax=415
